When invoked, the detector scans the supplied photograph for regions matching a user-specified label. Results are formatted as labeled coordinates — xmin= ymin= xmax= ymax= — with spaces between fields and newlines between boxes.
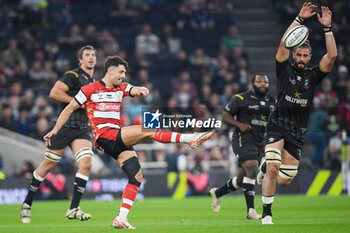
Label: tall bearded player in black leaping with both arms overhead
xmin=257 ymin=2 xmax=337 ymax=224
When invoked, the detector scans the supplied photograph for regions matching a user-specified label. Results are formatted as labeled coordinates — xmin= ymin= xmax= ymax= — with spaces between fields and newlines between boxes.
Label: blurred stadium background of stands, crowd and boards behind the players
xmin=0 ymin=0 xmax=350 ymax=203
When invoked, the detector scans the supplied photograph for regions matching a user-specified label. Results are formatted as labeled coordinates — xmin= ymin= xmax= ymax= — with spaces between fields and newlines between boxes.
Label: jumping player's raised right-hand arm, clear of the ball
xmin=317 ymin=6 xmax=337 ymax=73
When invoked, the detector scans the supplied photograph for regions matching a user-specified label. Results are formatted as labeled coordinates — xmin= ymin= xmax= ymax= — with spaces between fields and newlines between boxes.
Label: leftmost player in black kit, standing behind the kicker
xmin=21 ymin=45 xmax=96 ymax=223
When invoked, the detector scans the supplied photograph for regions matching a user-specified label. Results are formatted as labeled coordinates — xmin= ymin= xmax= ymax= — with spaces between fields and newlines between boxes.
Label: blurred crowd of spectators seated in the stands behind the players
xmin=0 ymin=0 xmax=350 ymax=177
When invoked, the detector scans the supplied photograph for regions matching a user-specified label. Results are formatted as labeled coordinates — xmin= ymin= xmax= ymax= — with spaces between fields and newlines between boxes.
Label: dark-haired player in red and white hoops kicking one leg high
xmin=44 ymin=56 xmax=215 ymax=229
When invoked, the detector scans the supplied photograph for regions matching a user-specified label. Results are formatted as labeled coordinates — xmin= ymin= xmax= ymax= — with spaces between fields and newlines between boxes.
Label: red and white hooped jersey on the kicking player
xmin=74 ymin=81 xmax=133 ymax=141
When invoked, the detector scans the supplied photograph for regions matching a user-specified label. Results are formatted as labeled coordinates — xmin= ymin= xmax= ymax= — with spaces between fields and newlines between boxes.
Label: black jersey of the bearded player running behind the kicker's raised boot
xmin=225 ymin=91 xmax=275 ymax=143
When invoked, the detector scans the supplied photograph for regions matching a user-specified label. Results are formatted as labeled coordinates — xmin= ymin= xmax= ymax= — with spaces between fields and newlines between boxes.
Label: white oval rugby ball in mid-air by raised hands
xmin=283 ymin=25 xmax=309 ymax=49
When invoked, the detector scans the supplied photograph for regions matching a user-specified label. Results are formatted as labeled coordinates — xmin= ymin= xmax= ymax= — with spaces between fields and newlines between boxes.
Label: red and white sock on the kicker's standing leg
xmin=117 ymin=184 xmax=140 ymax=220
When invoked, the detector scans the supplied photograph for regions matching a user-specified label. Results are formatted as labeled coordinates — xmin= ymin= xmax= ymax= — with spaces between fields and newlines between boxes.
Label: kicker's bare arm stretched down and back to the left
xmin=44 ymin=99 xmax=80 ymax=145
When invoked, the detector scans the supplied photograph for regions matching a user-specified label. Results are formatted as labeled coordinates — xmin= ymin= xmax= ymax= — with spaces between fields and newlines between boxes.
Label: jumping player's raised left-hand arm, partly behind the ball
xmin=276 ymin=2 xmax=317 ymax=62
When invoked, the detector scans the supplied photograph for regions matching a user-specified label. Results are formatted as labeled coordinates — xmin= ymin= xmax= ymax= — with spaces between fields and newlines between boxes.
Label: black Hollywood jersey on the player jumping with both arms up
xmin=270 ymin=60 xmax=328 ymax=139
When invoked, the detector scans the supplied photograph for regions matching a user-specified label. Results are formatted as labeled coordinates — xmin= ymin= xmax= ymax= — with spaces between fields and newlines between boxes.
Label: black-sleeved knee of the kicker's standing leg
xmin=122 ymin=156 xmax=143 ymax=187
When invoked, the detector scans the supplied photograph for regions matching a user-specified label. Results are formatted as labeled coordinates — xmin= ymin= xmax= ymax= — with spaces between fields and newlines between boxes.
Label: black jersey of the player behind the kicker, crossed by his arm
xmin=60 ymin=68 xmax=96 ymax=129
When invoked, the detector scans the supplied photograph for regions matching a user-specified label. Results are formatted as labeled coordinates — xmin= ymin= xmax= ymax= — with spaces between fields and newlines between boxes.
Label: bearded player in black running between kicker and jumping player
xmin=210 ymin=74 xmax=275 ymax=219
